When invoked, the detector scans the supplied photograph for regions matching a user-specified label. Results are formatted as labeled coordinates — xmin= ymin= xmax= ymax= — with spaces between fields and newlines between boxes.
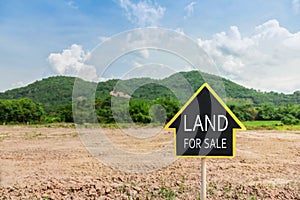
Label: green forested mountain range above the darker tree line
xmin=0 ymin=71 xmax=300 ymax=113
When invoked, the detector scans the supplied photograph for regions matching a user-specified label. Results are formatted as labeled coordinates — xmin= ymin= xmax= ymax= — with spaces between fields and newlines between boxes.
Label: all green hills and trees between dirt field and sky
xmin=0 ymin=71 xmax=300 ymax=124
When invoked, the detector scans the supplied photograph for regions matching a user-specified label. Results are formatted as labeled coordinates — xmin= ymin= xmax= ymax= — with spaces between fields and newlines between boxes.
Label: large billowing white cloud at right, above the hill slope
xmin=198 ymin=20 xmax=300 ymax=92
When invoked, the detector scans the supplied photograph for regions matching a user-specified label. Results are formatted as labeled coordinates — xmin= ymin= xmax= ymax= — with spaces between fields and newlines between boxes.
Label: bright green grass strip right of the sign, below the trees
xmin=243 ymin=121 xmax=300 ymax=131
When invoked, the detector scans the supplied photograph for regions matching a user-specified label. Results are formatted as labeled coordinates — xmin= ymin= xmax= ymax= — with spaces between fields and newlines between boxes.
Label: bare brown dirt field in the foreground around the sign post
xmin=0 ymin=126 xmax=300 ymax=199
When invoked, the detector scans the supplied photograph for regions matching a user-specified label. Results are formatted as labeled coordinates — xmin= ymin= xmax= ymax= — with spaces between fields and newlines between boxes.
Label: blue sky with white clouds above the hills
xmin=0 ymin=0 xmax=300 ymax=93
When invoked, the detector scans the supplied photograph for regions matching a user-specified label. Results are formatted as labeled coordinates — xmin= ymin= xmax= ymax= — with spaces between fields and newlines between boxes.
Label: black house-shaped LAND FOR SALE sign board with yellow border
xmin=165 ymin=83 xmax=246 ymax=158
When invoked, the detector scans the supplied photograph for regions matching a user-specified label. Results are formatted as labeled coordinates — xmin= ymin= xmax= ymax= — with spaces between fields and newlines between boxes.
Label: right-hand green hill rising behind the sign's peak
xmin=112 ymin=71 xmax=300 ymax=106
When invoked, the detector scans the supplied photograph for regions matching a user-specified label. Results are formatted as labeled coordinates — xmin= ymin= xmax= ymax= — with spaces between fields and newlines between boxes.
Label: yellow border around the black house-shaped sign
xmin=164 ymin=83 xmax=246 ymax=158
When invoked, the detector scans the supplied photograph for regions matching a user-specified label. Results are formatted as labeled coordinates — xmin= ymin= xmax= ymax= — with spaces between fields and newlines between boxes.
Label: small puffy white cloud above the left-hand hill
xmin=48 ymin=44 xmax=97 ymax=81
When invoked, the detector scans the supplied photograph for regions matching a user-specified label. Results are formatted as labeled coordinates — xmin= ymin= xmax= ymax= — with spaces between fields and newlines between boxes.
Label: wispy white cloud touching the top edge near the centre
xmin=119 ymin=0 xmax=166 ymax=27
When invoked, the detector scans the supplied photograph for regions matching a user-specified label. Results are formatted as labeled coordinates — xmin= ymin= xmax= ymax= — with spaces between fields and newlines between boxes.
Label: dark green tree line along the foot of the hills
xmin=0 ymin=96 xmax=300 ymax=124
